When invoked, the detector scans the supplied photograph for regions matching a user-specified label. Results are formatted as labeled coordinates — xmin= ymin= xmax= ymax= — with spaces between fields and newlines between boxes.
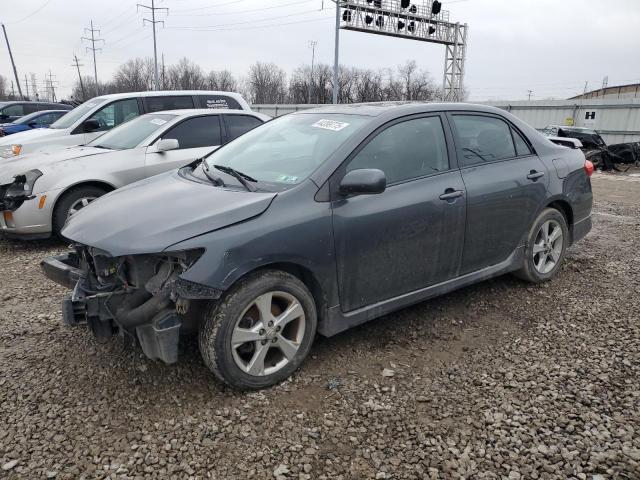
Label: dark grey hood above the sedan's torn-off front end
xmin=62 ymin=172 xmax=277 ymax=256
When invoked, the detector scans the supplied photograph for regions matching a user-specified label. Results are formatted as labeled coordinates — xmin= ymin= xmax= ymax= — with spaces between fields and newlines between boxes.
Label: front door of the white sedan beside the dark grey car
xmin=145 ymin=115 xmax=222 ymax=176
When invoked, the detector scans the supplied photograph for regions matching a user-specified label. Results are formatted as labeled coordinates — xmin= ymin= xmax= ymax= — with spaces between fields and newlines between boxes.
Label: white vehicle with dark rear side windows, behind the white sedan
xmin=0 ymin=90 xmax=251 ymax=158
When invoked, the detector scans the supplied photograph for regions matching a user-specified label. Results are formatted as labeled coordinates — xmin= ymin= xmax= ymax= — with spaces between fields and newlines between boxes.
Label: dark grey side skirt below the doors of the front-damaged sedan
xmin=318 ymin=246 xmax=524 ymax=337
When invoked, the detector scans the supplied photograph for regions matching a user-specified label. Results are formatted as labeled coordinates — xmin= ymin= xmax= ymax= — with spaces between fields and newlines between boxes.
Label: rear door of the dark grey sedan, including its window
xmin=450 ymin=113 xmax=549 ymax=274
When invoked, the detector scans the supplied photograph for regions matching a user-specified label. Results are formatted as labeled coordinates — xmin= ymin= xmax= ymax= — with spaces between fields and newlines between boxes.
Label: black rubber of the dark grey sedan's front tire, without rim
xmin=198 ymin=270 xmax=317 ymax=390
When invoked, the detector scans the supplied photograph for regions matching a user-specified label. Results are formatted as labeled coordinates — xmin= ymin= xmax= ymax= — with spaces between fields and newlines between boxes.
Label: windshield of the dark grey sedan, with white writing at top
xmin=202 ymin=113 xmax=369 ymax=185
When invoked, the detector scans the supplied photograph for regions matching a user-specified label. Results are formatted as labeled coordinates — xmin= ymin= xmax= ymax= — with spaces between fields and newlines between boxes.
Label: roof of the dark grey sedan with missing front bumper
xmin=295 ymin=102 xmax=516 ymax=117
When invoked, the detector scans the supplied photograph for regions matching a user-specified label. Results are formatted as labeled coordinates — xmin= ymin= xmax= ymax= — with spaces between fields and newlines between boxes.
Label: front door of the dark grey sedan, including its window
xmin=331 ymin=115 xmax=465 ymax=311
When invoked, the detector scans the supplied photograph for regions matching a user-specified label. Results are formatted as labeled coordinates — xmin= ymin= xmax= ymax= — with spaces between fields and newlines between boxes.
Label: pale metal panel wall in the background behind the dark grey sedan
xmin=252 ymin=98 xmax=640 ymax=144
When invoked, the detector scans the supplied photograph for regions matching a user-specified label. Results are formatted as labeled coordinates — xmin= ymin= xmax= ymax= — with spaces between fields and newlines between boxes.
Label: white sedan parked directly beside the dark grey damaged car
xmin=0 ymin=109 xmax=270 ymax=238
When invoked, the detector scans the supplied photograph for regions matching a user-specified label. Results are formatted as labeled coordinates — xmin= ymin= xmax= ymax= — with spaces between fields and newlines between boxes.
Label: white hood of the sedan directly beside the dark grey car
xmin=0 ymin=145 xmax=114 ymax=185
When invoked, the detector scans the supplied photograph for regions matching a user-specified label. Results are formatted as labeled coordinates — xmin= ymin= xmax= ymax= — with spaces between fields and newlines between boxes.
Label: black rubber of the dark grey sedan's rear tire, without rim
xmin=514 ymin=208 xmax=569 ymax=283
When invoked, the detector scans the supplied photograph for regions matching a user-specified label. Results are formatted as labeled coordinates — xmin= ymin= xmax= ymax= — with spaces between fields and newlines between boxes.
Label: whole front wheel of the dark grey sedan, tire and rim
xmin=199 ymin=270 xmax=317 ymax=390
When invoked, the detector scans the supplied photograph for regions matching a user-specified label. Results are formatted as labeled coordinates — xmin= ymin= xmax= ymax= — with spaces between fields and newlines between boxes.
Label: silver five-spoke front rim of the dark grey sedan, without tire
xmin=231 ymin=291 xmax=306 ymax=377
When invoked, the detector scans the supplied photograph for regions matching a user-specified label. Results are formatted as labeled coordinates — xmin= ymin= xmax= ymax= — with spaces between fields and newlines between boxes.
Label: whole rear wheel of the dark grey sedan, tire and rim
xmin=514 ymin=208 xmax=569 ymax=283
